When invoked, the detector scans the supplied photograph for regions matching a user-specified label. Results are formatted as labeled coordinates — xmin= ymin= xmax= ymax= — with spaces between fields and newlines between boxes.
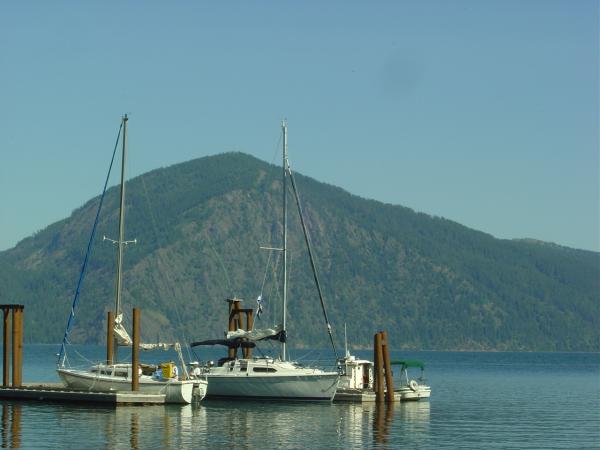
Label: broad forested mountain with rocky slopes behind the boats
xmin=0 ymin=153 xmax=600 ymax=351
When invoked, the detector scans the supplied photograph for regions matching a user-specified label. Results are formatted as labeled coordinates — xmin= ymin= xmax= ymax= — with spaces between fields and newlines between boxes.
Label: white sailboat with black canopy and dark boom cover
xmin=190 ymin=121 xmax=339 ymax=401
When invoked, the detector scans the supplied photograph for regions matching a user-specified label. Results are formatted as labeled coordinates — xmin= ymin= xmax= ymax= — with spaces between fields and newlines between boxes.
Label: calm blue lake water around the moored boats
xmin=0 ymin=345 xmax=600 ymax=449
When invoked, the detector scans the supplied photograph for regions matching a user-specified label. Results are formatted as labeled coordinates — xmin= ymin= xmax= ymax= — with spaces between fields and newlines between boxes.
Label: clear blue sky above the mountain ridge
xmin=0 ymin=0 xmax=600 ymax=250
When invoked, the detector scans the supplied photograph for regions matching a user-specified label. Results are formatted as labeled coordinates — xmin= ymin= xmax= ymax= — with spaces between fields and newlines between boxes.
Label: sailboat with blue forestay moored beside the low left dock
xmin=57 ymin=115 xmax=207 ymax=403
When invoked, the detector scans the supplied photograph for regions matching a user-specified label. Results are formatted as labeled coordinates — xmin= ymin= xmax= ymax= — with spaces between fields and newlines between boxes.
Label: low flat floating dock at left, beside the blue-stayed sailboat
xmin=0 ymin=383 xmax=165 ymax=406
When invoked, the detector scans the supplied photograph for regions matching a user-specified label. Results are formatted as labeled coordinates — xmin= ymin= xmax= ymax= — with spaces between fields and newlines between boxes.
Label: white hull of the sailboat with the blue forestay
xmin=57 ymin=369 xmax=199 ymax=403
